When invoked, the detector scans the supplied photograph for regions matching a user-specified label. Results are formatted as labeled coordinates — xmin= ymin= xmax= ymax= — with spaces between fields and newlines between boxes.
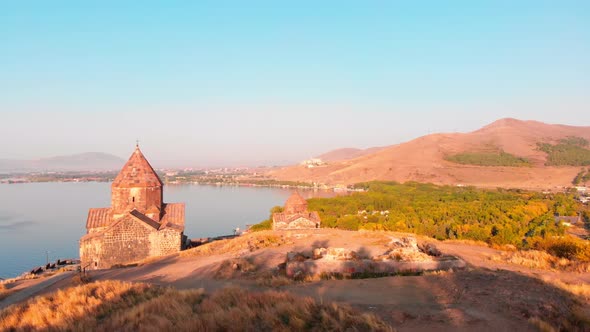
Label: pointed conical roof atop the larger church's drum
xmin=113 ymin=146 xmax=162 ymax=188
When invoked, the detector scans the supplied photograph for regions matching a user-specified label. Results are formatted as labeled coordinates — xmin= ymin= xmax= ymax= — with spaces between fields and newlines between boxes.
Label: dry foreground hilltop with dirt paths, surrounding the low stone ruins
xmin=0 ymin=229 xmax=590 ymax=331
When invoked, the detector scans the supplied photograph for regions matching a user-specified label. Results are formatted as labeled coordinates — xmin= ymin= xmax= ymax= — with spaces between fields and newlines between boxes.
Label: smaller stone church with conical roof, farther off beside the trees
xmin=272 ymin=192 xmax=320 ymax=230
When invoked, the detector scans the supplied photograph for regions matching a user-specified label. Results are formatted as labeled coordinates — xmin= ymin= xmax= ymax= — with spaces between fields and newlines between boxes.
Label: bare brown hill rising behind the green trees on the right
xmin=268 ymin=119 xmax=590 ymax=189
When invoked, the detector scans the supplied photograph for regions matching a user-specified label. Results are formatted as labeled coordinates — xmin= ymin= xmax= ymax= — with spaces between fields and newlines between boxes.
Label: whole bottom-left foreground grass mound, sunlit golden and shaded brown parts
xmin=0 ymin=281 xmax=393 ymax=331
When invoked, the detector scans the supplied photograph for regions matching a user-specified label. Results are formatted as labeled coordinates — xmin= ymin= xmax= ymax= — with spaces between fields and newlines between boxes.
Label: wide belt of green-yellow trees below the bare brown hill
xmin=309 ymin=182 xmax=580 ymax=247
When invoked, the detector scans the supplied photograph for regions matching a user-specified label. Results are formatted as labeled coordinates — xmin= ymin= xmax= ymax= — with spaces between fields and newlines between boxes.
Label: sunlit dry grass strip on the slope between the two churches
xmin=180 ymin=231 xmax=291 ymax=257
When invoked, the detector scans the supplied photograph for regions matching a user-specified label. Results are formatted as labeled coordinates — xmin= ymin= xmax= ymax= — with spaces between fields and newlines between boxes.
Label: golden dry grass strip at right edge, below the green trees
xmin=490 ymin=250 xmax=590 ymax=273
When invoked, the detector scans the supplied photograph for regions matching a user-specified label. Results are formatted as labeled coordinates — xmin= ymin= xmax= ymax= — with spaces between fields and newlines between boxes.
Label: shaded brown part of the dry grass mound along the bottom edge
xmin=105 ymin=288 xmax=391 ymax=331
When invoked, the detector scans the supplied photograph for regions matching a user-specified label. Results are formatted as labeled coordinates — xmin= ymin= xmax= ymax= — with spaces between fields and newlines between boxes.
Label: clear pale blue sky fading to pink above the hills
xmin=0 ymin=0 xmax=590 ymax=166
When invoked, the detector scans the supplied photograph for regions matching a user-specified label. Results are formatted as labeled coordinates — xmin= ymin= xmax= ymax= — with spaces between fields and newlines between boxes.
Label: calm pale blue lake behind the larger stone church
xmin=0 ymin=182 xmax=331 ymax=278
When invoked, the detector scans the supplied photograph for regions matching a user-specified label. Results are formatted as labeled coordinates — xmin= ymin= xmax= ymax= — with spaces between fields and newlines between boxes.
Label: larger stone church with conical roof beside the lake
xmin=80 ymin=146 xmax=186 ymax=269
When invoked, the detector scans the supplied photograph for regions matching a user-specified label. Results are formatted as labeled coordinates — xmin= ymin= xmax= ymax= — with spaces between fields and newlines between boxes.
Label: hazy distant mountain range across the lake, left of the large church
xmin=0 ymin=152 xmax=125 ymax=173
